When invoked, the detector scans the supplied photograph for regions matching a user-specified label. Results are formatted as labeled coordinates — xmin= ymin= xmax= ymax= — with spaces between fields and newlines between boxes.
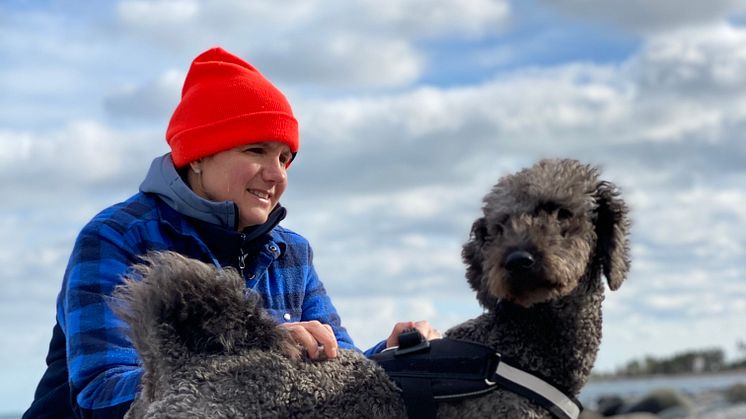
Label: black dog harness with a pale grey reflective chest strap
xmin=371 ymin=330 xmax=583 ymax=419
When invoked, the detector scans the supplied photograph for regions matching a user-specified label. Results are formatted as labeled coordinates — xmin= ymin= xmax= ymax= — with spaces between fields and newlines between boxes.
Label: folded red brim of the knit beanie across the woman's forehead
xmin=167 ymin=112 xmax=298 ymax=168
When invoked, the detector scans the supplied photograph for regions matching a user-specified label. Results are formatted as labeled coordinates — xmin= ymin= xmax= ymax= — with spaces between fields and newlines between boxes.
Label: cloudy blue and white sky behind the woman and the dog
xmin=0 ymin=0 xmax=746 ymax=413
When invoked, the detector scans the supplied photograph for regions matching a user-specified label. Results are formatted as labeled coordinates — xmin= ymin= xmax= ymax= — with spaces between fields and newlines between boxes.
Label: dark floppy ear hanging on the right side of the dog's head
xmin=595 ymin=181 xmax=630 ymax=290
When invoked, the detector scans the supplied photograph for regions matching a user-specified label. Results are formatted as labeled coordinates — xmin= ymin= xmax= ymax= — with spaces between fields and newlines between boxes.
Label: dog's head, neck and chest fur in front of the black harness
xmin=439 ymin=160 xmax=630 ymax=418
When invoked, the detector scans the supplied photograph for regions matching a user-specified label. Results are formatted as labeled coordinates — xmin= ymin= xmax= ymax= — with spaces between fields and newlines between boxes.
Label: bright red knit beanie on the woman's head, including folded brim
xmin=166 ymin=48 xmax=299 ymax=168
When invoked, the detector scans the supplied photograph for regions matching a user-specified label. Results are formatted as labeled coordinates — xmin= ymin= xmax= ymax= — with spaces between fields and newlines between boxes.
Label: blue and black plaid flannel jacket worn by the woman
xmin=57 ymin=192 xmax=354 ymax=410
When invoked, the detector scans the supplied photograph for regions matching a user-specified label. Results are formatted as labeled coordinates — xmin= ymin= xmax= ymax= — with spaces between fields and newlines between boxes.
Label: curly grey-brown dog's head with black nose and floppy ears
xmin=462 ymin=160 xmax=630 ymax=308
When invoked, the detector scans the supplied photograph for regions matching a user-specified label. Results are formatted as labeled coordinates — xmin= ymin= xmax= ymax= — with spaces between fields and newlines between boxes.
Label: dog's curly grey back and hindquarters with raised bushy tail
xmin=114 ymin=252 xmax=404 ymax=418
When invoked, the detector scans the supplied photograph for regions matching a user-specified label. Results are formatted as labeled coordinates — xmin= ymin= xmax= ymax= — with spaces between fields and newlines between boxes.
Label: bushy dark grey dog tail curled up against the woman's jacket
xmin=112 ymin=252 xmax=296 ymax=371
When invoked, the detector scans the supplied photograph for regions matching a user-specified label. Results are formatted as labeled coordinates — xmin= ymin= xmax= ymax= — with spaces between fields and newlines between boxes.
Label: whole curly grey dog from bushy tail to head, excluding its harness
xmin=115 ymin=160 xmax=629 ymax=418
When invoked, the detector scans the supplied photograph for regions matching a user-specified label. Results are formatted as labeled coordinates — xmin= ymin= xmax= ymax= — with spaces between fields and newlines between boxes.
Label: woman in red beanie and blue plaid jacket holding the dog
xmin=24 ymin=48 xmax=438 ymax=418
